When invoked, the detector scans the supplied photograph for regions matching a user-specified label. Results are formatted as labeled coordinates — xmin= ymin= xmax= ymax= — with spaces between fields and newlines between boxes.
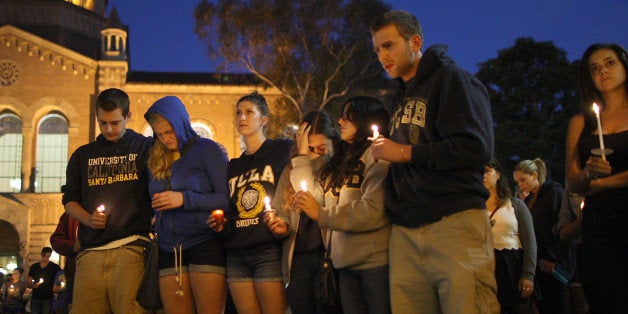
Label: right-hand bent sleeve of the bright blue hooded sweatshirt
xmin=182 ymin=143 xmax=229 ymax=212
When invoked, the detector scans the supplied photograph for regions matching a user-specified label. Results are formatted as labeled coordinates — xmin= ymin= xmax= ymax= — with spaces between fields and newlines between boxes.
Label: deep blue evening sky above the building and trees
xmin=108 ymin=0 xmax=628 ymax=73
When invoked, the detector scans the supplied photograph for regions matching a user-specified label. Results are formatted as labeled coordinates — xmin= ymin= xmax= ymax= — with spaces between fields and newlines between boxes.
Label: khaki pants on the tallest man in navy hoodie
xmin=390 ymin=209 xmax=499 ymax=314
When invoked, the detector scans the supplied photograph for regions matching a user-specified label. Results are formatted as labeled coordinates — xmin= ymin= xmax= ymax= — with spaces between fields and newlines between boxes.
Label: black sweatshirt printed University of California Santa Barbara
xmin=61 ymin=119 xmax=152 ymax=249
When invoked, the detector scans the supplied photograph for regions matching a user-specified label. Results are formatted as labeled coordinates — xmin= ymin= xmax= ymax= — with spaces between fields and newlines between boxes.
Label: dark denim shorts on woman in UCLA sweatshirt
xmin=227 ymin=244 xmax=283 ymax=282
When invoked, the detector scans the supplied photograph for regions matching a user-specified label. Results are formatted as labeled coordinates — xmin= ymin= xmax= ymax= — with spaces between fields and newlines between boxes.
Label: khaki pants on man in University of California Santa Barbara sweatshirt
xmin=71 ymin=245 xmax=146 ymax=314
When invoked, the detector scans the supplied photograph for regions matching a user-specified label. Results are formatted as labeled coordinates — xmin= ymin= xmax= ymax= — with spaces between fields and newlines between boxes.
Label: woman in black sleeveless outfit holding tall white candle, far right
xmin=565 ymin=44 xmax=628 ymax=313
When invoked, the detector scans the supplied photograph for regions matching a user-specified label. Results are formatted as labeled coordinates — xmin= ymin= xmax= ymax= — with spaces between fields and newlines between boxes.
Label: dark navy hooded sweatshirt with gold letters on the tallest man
xmin=386 ymin=45 xmax=493 ymax=228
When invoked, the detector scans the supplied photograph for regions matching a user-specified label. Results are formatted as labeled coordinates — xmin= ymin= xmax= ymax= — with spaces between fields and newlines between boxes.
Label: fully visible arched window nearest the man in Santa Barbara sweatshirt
xmin=34 ymin=113 xmax=68 ymax=192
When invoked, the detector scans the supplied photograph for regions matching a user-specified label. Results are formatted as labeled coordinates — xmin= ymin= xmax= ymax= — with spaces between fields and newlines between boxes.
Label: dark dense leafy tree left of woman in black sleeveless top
xmin=476 ymin=38 xmax=580 ymax=182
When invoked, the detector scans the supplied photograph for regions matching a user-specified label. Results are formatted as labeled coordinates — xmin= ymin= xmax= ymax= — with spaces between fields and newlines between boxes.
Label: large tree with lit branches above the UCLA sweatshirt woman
xmin=194 ymin=0 xmax=390 ymax=117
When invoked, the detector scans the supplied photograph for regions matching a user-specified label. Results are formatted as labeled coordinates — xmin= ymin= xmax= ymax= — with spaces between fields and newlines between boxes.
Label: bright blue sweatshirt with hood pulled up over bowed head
xmin=144 ymin=96 xmax=229 ymax=252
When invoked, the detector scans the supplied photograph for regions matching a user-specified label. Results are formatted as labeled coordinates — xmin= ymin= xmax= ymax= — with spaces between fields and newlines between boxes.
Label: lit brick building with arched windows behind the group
xmin=0 ymin=0 xmax=280 ymax=269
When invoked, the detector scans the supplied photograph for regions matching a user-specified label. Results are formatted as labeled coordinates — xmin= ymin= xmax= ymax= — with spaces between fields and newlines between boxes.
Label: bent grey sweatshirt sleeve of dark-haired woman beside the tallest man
xmin=318 ymin=148 xmax=390 ymax=232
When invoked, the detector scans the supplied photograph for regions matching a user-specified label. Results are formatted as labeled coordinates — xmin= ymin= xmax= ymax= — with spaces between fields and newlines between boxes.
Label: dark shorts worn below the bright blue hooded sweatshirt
xmin=159 ymin=239 xmax=227 ymax=277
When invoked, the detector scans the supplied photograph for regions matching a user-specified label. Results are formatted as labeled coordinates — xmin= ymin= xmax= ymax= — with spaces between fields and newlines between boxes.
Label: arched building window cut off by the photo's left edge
xmin=0 ymin=112 xmax=22 ymax=192
